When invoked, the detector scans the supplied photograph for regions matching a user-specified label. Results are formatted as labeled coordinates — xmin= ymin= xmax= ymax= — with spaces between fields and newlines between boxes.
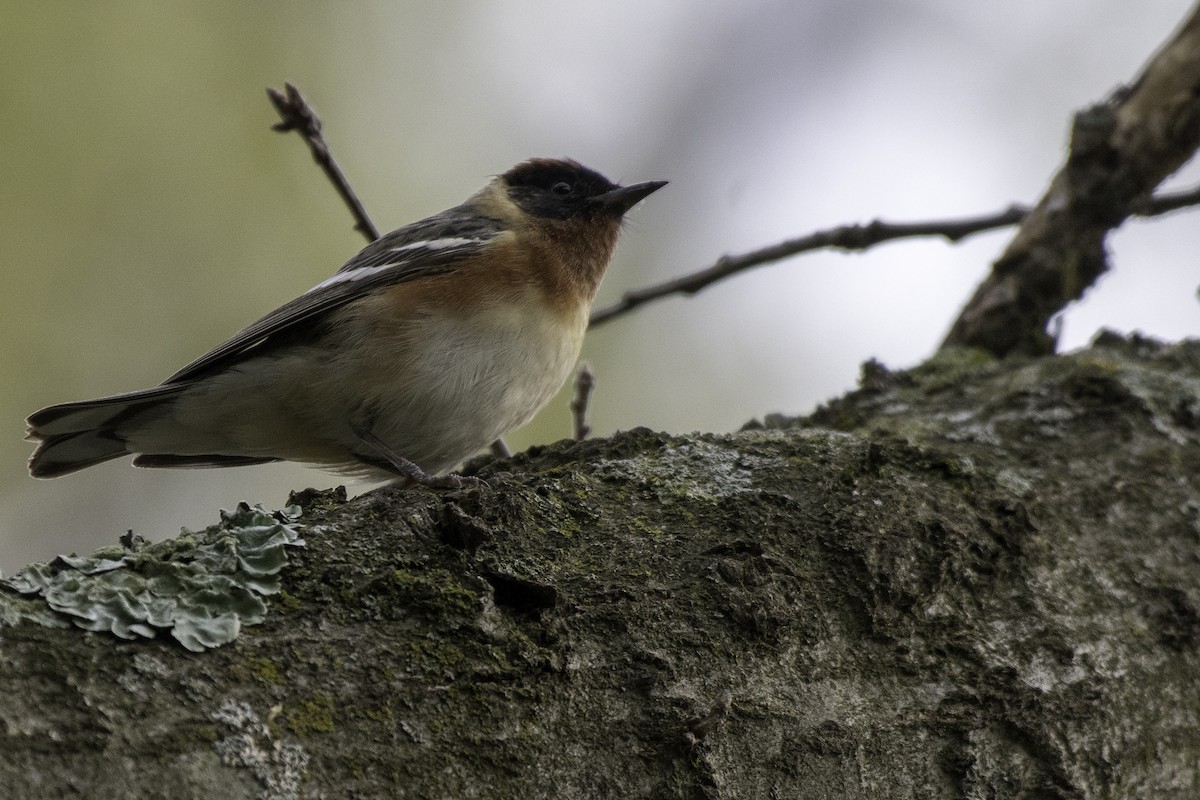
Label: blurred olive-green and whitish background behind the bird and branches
xmin=0 ymin=0 xmax=1200 ymax=575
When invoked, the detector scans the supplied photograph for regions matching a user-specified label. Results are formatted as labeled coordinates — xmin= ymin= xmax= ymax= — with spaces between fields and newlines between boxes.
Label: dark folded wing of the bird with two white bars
xmin=163 ymin=206 xmax=503 ymax=385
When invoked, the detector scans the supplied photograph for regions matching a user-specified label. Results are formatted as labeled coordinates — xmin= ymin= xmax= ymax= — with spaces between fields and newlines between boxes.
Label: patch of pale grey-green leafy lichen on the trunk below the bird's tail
xmin=0 ymin=504 xmax=304 ymax=652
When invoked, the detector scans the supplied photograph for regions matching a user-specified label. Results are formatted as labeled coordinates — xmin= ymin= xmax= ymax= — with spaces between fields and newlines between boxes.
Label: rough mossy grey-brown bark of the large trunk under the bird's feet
xmin=0 ymin=337 xmax=1200 ymax=800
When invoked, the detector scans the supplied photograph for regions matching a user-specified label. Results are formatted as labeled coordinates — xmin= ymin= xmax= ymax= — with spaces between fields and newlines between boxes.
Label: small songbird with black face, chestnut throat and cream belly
xmin=26 ymin=158 xmax=666 ymax=486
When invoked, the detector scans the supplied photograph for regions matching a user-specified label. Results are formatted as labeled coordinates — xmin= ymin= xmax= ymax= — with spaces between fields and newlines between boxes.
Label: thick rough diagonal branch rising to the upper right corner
xmin=942 ymin=6 xmax=1200 ymax=356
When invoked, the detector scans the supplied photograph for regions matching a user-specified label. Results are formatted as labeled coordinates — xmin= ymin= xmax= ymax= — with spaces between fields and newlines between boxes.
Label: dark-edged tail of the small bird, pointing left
xmin=25 ymin=384 xmax=186 ymax=477
